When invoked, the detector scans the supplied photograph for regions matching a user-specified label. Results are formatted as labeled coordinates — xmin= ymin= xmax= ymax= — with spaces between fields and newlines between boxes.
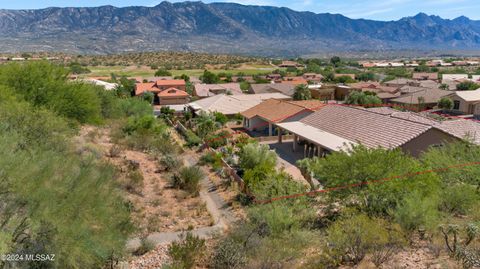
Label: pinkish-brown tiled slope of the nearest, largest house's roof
xmin=300 ymin=105 xmax=432 ymax=149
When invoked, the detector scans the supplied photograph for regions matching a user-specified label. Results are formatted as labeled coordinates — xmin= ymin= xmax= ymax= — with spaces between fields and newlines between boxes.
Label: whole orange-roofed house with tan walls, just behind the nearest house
xmin=241 ymin=99 xmax=325 ymax=136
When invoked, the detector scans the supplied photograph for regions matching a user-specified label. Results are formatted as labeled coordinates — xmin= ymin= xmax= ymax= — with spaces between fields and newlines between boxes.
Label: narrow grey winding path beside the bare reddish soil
xmin=127 ymin=151 xmax=236 ymax=251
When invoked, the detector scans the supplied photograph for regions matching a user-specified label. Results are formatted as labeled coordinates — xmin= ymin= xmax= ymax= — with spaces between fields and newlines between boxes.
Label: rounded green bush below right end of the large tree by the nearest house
xmin=392 ymin=192 xmax=439 ymax=231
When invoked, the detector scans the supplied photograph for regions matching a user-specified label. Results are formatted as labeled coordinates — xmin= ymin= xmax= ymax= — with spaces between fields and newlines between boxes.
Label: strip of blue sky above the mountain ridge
xmin=0 ymin=0 xmax=480 ymax=20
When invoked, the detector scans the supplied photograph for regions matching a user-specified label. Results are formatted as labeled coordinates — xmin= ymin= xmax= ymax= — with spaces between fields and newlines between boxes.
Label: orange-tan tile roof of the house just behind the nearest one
xmin=242 ymin=99 xmax=325 ymax=122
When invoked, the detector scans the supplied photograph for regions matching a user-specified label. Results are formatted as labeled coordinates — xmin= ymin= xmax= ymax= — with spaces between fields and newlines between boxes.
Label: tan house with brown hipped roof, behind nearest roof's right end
xmin=390 ymin=88 xmax=451 ymax=111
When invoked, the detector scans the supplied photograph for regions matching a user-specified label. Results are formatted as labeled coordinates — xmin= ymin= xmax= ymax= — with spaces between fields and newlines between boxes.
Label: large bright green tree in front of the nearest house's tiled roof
xmin=309 ymin=146 xmax=439 ymax=216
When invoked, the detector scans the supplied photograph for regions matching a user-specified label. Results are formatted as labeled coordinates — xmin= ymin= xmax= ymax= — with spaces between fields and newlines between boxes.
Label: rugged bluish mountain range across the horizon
xmin=0 ymin=2 xmax=480 ymax=56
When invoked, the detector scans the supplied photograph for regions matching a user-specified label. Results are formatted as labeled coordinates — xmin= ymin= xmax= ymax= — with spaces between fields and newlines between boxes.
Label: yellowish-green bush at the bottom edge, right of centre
xmin=326 ymin=214 xmax=404 ymax=264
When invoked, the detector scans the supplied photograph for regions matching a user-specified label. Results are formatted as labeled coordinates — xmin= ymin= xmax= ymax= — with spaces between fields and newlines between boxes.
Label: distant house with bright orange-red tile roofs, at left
xmin=135 ymin=80 xmax=189 ymax=105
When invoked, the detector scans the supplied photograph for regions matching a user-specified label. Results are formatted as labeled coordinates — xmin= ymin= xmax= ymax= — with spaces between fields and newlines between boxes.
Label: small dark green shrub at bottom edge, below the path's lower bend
xmin=168 ymin=233 xmax=205 ymax=269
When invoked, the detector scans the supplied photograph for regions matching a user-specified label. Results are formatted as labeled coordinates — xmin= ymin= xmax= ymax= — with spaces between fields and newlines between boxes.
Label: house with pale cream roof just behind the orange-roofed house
xmin=189 ymin=93 xmax=291 ymax=116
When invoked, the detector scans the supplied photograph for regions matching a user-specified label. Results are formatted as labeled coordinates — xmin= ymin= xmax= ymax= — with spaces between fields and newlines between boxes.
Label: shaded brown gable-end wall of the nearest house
xmin=401 ymin=129 xmax=458 ymax=157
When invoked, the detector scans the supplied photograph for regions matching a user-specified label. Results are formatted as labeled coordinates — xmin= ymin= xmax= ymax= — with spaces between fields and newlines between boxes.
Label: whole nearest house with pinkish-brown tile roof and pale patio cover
xmin=277 ymin=105 xmax=458 ymax=157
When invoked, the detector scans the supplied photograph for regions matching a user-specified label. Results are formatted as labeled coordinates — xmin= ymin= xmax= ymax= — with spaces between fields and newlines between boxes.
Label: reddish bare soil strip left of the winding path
xmin=78 ymin=126 xmax=213 ymax=236
